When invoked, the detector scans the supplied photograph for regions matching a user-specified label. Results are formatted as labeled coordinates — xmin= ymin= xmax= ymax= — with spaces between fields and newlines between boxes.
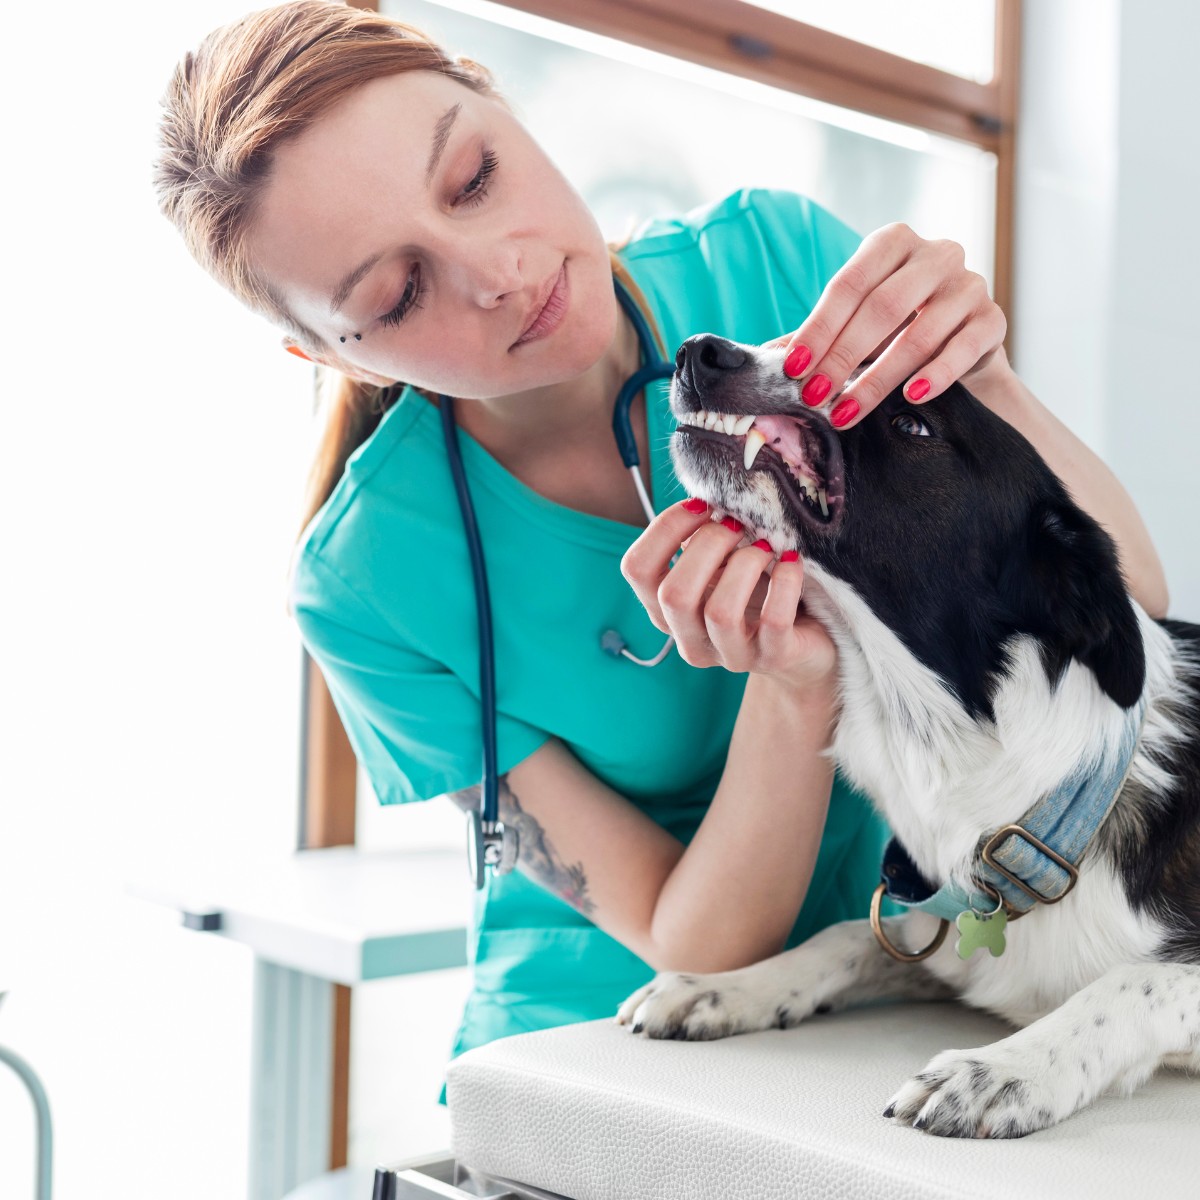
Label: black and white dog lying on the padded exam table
xmin=617 ymin=335 xmax=1200 ymax=1138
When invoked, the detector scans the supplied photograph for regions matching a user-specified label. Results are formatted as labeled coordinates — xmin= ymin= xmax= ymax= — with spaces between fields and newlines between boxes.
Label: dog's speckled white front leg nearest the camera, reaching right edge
xmin=883 ymin=962 xmax=1200 ymax=1138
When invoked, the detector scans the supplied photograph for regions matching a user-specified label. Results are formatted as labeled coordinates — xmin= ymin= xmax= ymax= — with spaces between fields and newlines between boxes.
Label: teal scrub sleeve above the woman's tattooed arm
xmin=292 ymin=556 xmax=550 ymax=804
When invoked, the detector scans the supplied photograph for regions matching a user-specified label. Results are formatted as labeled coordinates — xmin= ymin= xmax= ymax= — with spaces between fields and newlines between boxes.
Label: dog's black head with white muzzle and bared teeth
xmin=671 ymin=334 xmax=1145 ymax=718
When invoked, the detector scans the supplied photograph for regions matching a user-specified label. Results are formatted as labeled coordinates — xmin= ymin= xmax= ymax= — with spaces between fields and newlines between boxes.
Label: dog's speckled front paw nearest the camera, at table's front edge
xmin=883 ymin=1046 xmax=1074 ymax=1138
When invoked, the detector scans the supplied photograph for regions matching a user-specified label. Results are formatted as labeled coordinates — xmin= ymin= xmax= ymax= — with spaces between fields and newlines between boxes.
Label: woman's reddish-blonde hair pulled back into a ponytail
xmin=154 ymin=0 xmax=667 ymax=529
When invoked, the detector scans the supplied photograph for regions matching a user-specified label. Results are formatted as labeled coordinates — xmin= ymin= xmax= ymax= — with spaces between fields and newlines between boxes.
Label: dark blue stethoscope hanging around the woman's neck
xmin=438 ymin=276 xmax=674 ymax=888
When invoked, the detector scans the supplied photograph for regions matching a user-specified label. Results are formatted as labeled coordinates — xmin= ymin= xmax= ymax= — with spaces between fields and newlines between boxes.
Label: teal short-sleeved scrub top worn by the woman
xmin=290 ymin=188 xmax=888 ymax=1099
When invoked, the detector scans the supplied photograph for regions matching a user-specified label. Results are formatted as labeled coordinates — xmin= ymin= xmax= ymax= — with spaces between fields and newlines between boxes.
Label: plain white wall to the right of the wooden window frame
xmin=1013 ymin=0 xmax=1200 ymax=620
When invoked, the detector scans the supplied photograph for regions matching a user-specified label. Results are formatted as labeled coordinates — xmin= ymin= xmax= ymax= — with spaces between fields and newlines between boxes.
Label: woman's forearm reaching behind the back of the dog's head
xmin=964 ymin=362 xmax=1168 ymax=617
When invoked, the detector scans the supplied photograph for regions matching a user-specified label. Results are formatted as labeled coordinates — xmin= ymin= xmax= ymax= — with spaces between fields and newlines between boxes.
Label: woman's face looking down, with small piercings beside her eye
xmin=250 ymin=71 xmax=617 ymax=400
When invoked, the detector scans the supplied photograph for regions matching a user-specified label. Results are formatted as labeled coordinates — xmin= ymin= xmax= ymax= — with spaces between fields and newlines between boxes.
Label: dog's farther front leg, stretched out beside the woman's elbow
xmin=617 ymin=917 xmax=954 ymax=1042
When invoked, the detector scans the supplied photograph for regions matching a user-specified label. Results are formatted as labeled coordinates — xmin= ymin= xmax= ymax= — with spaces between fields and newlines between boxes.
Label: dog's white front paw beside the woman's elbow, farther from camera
xmin=617 ymin=971 xmax=799 ymax=1042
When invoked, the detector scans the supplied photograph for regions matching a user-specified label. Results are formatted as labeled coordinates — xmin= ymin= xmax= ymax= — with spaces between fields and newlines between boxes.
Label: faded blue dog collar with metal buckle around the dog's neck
xmin=881 ymin=701 xmax=1146 ymax=922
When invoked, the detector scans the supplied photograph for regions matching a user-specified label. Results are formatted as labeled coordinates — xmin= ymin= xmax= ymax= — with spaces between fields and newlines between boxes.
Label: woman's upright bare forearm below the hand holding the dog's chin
xmin=650 ymin=674 xmax=834 ymax=971
